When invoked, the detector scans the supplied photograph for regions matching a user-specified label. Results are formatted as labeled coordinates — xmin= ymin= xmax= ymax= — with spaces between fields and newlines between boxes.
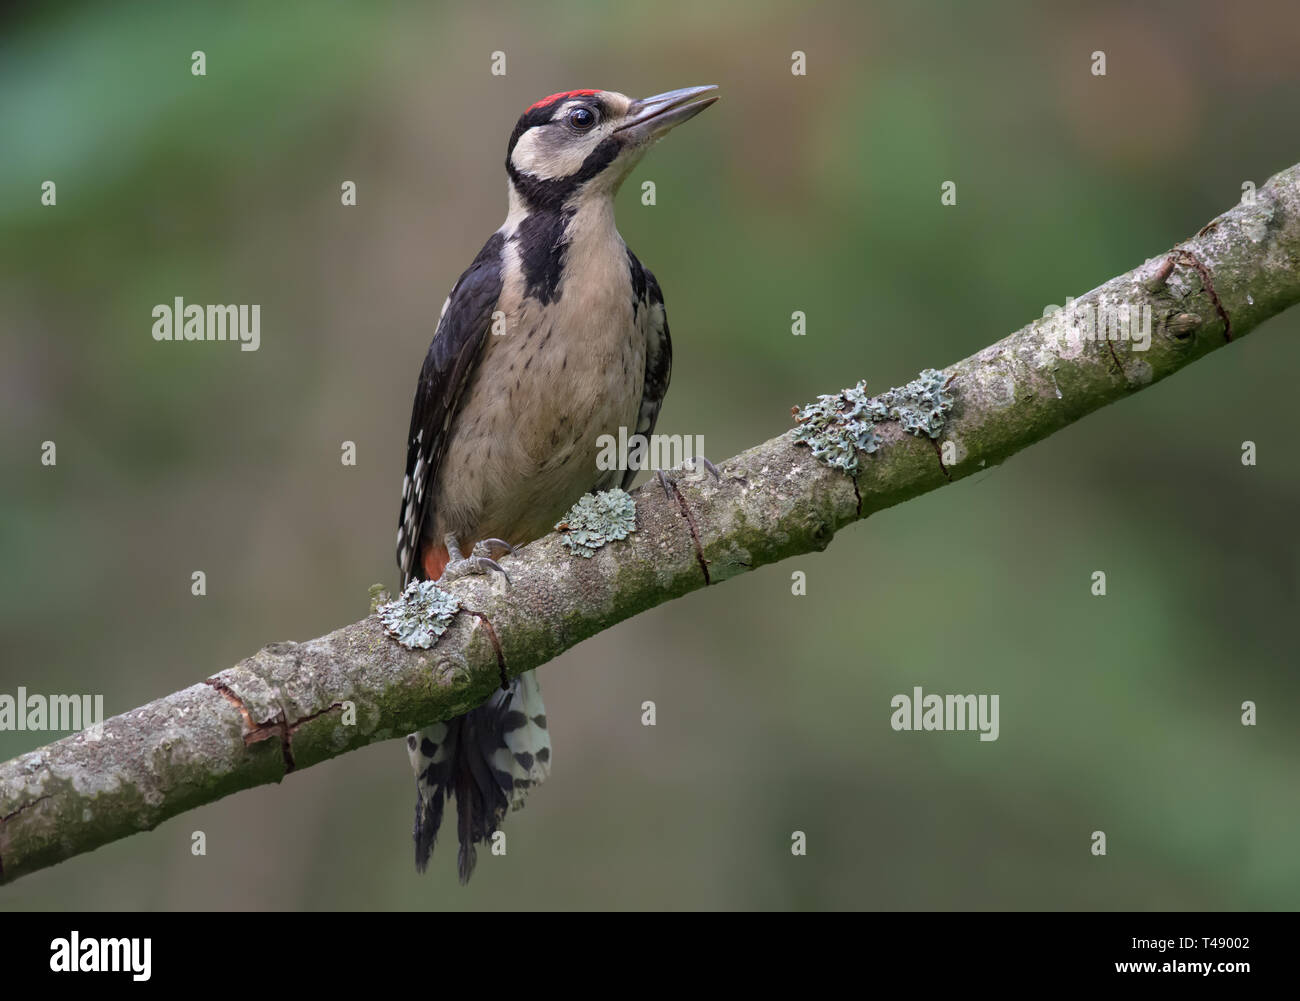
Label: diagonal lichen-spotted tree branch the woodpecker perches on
xmin=0 ymin=165 xmax=1300 ymax=881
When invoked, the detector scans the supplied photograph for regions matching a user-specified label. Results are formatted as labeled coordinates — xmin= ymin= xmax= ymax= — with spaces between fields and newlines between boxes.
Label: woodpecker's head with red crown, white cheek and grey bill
xmin=506 ymin=86 xmax=718 ymax=209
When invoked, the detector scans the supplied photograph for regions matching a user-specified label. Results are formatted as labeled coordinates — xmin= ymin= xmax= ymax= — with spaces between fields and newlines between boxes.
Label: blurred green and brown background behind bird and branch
xmin=0 ymin=0 xmax=1300 ymax=909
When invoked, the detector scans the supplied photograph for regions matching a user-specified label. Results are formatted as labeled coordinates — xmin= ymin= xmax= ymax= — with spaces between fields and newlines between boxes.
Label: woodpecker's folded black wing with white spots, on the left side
xmin=398 ymin=233 xmax=504 ymax=588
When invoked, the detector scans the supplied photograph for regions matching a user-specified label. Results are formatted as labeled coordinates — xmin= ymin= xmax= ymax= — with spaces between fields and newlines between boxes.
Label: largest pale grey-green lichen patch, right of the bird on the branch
xmin=794 ymin=368 xmax=953 ymax=476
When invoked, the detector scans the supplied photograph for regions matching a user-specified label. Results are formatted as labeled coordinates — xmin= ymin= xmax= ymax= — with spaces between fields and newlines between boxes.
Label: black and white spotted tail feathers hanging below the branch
xmin=407 ymin=671 xmax=551 ymax=883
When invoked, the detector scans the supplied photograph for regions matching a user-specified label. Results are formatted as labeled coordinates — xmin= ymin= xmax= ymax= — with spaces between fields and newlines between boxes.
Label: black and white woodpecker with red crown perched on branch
xmin=397 ymin=86 xmax=718 ymax=883
